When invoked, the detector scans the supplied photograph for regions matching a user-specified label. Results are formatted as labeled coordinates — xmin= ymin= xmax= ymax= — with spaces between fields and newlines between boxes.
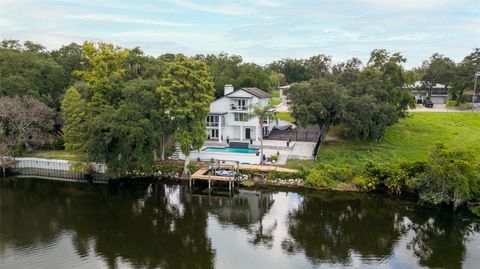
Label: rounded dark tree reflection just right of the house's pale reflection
xmin=282 ymin=193 xmax=403 ymax=264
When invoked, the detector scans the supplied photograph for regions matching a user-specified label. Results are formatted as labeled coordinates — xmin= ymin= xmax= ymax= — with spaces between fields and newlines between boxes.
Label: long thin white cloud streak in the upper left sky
xmin=63 ymin=14 xmax=193 ymax=27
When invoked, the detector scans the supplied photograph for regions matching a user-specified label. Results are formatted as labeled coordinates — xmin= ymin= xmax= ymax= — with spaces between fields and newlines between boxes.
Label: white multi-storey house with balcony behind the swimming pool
xmin=205 ymin=84 xmax=273 ymax=142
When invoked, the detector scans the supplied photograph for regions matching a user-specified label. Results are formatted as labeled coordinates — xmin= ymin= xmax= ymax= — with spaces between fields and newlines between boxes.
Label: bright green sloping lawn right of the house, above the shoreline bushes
xmin=287 ymin=112 xmax=480 ymax=168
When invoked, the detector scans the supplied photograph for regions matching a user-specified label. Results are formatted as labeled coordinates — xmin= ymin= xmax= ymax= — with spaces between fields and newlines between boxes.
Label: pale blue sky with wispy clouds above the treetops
xmin=0 ymin=0 xmax=480 ymax=67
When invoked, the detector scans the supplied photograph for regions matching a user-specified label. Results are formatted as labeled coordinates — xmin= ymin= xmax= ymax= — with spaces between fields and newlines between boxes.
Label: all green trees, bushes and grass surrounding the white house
xmin=0 ymin=40 xmax=480 ymax=213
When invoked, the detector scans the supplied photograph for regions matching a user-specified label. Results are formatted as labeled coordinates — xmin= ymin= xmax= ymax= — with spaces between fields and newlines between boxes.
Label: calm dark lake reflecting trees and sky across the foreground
xmin=0 ymin=179 xmax=480 ymax=269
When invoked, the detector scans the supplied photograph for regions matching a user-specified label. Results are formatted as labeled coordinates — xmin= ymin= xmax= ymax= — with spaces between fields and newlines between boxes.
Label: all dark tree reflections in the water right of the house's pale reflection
xmin=282 ymin=193 xmax=479 ymax=268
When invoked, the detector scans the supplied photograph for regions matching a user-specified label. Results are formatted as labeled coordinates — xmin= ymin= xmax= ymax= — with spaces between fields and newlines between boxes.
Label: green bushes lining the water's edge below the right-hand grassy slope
xmin=290 ymin=143 xmax=480 ymax=215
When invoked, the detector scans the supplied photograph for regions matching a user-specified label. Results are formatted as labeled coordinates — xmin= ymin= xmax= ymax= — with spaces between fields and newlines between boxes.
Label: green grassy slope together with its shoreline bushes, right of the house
xmin=287 ymin=112 xmax=480 ymax=213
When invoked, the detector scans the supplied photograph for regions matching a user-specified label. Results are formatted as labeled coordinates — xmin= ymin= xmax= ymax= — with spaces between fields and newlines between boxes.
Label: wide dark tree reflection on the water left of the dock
xmin=0 ymin=178 xmax=214 ymax=268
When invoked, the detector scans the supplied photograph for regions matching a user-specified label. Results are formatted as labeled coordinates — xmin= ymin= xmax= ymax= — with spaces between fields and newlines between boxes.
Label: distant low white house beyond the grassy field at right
xmin=408 ymin=81 xmax=451 ymax=104
